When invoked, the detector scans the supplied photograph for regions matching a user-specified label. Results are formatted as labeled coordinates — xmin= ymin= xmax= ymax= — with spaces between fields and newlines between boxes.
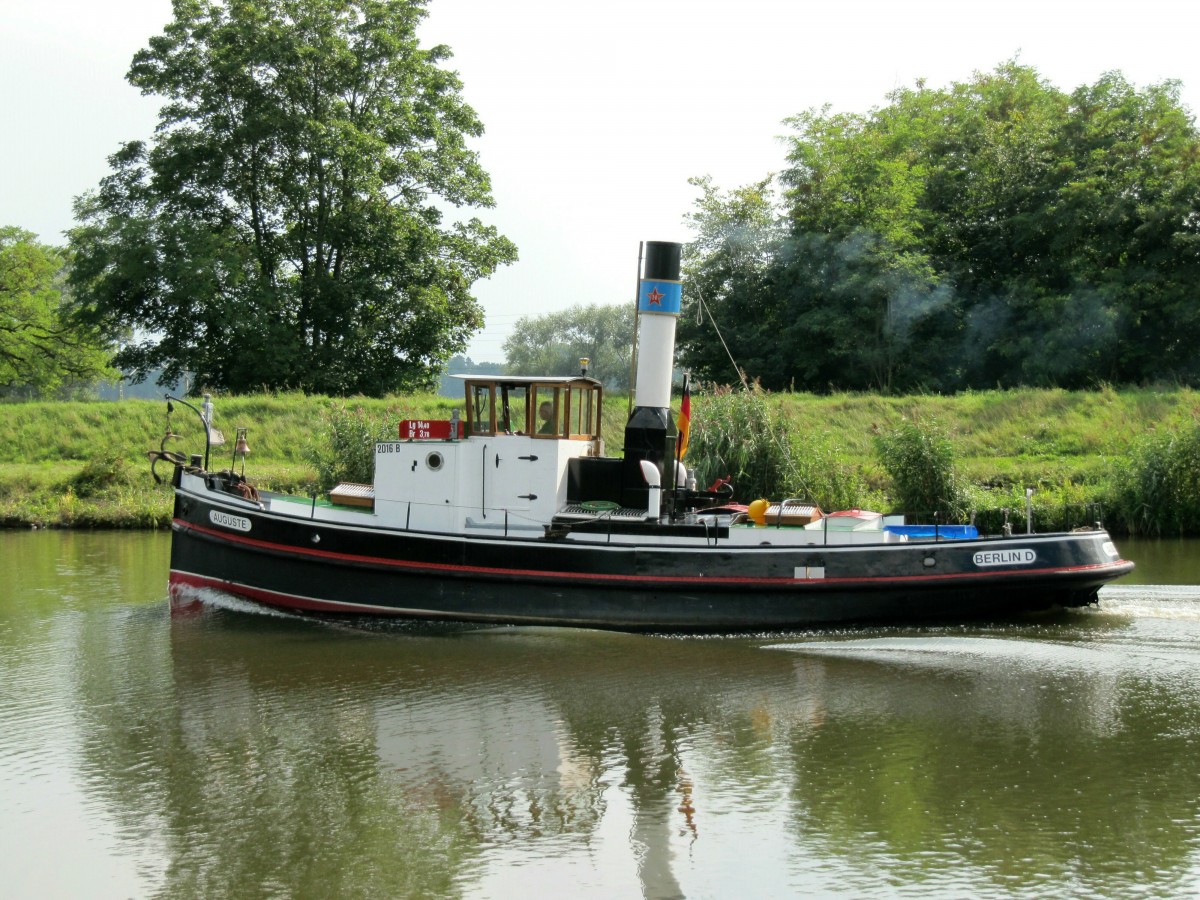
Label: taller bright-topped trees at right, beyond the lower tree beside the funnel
xmin=785 ymin=61 xmax=1200 ymax=388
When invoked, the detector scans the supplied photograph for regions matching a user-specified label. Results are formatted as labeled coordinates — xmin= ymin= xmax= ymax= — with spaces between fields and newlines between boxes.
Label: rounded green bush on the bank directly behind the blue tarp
xmin=875 ymin=419 xmax=970 ymax=522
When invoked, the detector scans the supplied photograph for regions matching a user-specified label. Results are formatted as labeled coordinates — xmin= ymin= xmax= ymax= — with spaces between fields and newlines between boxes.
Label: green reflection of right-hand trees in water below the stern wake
xmin=790 ymin=642 xmax=1200 ymax=893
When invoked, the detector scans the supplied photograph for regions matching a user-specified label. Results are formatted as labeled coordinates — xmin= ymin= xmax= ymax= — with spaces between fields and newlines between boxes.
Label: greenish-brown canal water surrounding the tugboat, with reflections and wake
xmin=0 ymin=532 xmax=1200 ymax=898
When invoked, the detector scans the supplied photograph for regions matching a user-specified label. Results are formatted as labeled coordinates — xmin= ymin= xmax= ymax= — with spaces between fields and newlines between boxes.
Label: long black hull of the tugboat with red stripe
xmin=170 ymin=491 xmax=1133 ymax=631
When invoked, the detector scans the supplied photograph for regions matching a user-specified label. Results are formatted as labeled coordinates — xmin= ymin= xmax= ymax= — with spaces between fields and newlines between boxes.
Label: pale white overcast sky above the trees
xmin=0 ymin=0 xmax=1200 ymax=361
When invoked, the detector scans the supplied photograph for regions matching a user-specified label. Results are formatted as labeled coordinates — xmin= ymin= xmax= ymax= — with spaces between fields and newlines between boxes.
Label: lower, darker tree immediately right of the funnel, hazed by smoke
xmin=678 ymin=174 xmax=944 ymax=390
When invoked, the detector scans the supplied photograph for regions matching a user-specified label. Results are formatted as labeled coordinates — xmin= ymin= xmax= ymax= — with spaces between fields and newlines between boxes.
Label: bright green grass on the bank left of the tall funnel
xmin=0 ymin=394 xmax=626 ymax=528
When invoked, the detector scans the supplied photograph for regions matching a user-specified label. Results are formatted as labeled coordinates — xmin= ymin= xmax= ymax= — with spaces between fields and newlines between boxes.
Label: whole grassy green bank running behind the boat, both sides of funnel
xmin=0 ymin=389 xmax=1200 ymax=528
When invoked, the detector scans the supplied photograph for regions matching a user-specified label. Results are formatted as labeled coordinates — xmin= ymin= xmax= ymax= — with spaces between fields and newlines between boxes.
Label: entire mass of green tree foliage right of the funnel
xmin=682 ymin=61 xmax=1200 ymax=391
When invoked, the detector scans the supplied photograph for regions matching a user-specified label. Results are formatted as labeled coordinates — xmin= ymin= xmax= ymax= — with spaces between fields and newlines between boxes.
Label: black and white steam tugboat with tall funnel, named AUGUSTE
xmin=159 ymin=242 xmax=1133 ymax=632
